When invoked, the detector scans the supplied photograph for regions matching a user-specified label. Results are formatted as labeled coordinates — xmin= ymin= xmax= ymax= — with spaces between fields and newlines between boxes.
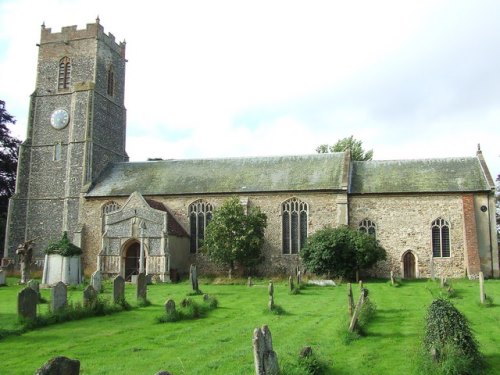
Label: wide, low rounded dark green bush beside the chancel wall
xmin=300 ymin=226 xmax=386 ymax=278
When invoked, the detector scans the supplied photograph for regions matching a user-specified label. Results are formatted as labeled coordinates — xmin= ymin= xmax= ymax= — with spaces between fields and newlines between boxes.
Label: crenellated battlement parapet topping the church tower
xmin=40 ymin=18 xmax=126 ymax=57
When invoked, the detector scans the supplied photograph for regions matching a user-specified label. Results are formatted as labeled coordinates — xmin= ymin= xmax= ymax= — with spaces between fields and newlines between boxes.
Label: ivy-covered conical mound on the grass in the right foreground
xmin=423 ymin=298 xmax=483 ymax=374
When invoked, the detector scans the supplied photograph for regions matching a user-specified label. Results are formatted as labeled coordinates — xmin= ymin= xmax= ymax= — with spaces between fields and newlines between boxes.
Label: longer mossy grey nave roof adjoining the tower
xmin=87 ymin=152 xmax=347 ymax=197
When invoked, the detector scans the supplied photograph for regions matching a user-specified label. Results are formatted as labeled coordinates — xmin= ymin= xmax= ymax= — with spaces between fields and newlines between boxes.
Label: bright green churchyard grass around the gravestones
xmin=0 ymin=279 xmax=500 ymax=375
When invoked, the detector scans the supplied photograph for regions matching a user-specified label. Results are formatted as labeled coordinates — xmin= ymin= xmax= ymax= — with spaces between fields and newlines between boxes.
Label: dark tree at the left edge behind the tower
xmin=0 ymin=100 xmax=21 ymax=253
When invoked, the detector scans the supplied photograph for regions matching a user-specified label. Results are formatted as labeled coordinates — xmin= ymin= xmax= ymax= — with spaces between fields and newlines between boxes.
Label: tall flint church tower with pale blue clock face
xmin=4 ymin=19 xmax=128 ymax=258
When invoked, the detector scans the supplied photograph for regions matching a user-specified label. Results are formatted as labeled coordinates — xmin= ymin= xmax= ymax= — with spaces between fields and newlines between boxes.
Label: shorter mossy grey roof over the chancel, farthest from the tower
xmin=349 ymin=157 xmax=491 ymax=194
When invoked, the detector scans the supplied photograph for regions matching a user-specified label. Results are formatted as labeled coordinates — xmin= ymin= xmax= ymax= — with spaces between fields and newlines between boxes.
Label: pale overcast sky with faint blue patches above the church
xmin=0 ymin=0 xmax=500 ymax=182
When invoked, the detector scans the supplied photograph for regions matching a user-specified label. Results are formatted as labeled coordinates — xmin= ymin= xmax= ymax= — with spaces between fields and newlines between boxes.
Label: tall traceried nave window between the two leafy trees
xmin=281 ymin=198 xmax=308 ymax=254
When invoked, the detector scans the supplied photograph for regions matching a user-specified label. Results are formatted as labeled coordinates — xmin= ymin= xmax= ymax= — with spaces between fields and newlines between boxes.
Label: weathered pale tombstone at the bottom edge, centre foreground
xmin=252 ymin=326 xmax=280 ymax=375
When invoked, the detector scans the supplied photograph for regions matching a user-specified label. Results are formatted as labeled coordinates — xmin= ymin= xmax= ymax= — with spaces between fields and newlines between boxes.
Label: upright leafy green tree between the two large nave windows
xmin=202 ymin=197 xmax=267 ymax=272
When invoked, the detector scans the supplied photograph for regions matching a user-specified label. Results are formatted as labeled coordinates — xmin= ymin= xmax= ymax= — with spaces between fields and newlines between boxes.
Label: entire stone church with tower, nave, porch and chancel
xmin=4 ymin=19 xmax=499 ymax=281
